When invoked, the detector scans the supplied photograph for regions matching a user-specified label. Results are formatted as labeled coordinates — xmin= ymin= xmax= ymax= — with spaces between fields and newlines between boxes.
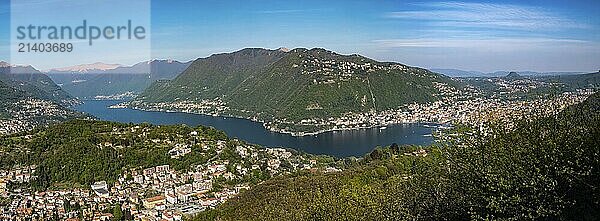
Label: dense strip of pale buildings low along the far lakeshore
xmin=279 ymin=88 xmax=593 ymax=135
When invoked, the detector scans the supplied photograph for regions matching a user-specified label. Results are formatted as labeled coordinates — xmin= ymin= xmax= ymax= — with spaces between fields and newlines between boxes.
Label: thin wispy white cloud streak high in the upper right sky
xmin=388 ymin=2 xmax=586 ymax=30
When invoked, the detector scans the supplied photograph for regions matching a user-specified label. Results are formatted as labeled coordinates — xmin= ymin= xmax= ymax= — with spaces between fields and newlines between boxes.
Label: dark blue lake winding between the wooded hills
xmin=74 ymin=100 xmax=433 ymax=157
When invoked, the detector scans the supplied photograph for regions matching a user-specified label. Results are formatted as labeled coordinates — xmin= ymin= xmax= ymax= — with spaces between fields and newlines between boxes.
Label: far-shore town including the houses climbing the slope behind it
xmin=265 ymin=78 xmax=594 ymax=136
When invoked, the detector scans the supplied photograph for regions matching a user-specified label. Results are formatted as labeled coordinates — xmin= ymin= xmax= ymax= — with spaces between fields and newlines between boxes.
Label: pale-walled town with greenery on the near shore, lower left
xmin=0 ymin=126 xmax=340 ymax=220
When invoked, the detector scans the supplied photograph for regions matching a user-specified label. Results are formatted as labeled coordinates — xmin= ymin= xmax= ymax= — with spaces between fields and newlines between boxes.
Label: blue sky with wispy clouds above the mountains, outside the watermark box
xmin=0 ymin=0 xmax=600 ymax=72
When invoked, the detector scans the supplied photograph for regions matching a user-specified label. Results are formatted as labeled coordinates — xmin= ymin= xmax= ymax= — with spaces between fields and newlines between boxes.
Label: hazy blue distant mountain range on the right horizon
xmin=431 ymin=68 xmax=584 ymax=77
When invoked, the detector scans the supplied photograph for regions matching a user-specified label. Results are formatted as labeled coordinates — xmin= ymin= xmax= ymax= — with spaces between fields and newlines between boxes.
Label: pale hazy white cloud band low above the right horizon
xmin=372 ymin=37 xmax=600 ymax=72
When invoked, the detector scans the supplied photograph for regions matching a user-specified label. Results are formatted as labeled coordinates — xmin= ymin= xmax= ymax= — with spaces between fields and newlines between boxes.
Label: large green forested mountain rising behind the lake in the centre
xmin=131 ymin=48 xmax=460 ymax=132
